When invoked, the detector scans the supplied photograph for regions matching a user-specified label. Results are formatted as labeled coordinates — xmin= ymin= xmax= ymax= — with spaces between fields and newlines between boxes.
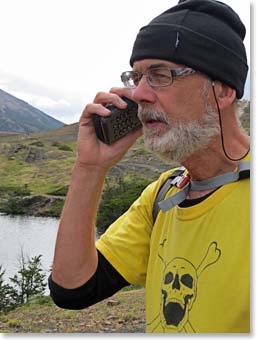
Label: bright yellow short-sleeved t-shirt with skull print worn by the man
xmin=97 ymin=159 xmax=250 ymax=333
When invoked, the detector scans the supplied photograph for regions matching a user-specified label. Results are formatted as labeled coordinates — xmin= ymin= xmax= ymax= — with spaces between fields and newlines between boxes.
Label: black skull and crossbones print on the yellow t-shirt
xmin=148 ymin=240 xmax=221 ymax=333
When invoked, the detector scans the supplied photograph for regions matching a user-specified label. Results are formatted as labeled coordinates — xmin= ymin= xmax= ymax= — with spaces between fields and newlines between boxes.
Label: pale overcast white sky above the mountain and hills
xmin=0 ymin=0 xmax=250 ymax=124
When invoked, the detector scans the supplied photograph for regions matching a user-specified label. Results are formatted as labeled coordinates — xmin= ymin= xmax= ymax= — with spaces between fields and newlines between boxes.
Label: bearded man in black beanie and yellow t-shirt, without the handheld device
xmin=49 ymin=0 xmax=250 ymax=333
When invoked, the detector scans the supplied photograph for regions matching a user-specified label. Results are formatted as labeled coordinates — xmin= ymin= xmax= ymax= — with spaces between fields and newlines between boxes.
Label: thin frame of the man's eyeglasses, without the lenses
xmin=120 ymin=66 xmax=194 ymax=88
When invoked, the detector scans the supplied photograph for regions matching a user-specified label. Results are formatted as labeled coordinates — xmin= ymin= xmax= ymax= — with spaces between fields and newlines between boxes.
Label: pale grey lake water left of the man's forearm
xmin=0 ymin=215 xmax=59 ymax=281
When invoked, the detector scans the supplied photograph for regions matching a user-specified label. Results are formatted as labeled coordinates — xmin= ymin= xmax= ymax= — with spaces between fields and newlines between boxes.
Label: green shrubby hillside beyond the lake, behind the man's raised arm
xmin=0 ymin=102 xmax=250 ymax=216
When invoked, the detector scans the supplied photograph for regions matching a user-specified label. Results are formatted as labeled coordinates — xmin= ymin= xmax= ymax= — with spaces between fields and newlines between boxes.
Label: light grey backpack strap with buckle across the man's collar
xmin=157 ymin=162 xmax=250 ymax=212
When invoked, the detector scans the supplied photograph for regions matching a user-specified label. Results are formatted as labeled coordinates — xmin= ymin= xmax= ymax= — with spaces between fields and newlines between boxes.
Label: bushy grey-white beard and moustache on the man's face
xmin=138 ymin=103 xmax=220 ymax=163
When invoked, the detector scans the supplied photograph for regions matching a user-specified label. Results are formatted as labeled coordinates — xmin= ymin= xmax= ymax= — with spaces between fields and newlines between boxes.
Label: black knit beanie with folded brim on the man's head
xmin=130 ymin=0 xmax=248 ymax=98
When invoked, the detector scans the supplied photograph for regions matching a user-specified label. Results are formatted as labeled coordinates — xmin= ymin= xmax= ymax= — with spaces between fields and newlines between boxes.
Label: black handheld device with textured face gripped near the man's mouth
xmin=93 ymin=97 xmax=142 ymax=144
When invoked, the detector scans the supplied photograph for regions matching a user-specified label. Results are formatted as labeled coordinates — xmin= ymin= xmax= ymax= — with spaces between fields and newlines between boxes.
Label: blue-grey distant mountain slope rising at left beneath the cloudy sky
xmin=0 ymin=89 xmax=65 ymax=133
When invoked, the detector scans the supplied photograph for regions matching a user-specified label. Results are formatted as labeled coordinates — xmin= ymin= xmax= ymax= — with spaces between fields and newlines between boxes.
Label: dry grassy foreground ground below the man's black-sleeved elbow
xmin=0 ymin=288 xmax=145 ymax=333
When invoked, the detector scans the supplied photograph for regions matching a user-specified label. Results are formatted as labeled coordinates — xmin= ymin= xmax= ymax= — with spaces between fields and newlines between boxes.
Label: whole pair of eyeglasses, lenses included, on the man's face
xmin=121 ymin=67 xmax=196 ymax=88
